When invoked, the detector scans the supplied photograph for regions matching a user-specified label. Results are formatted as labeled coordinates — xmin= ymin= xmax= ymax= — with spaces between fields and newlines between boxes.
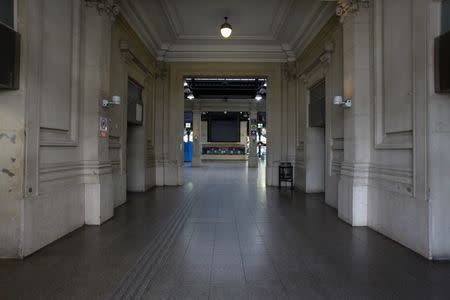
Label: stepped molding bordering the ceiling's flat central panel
xmin=121 ymin=0 xmax=335 ymax=62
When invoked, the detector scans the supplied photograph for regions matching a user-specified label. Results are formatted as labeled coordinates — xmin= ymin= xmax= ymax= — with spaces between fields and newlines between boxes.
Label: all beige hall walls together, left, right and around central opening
xmin=0 ymin=0 xmax=450 ymax=258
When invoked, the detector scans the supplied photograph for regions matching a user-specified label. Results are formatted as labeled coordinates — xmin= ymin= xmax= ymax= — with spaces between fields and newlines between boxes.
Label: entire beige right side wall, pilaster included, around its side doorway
xmin=296 ymin=0 xmax=450 ymax=258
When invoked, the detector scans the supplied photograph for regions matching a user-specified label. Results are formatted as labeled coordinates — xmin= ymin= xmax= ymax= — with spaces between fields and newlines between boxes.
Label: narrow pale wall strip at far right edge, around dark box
xmin=428 ymin=0 xmax=450 ymax=260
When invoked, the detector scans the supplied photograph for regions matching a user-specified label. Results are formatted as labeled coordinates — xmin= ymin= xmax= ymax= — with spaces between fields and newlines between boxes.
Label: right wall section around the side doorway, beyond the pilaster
xmin=295 ymin=18 xmax=344 ymax=204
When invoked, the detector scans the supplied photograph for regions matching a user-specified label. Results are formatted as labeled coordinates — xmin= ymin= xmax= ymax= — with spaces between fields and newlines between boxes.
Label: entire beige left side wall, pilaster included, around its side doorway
xmin=0 ymin=0 xmax=154 ymax=257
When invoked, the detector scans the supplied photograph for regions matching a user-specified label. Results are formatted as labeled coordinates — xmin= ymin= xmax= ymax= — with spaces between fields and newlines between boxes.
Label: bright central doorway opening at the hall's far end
xmin=183 ymin=76 xmax=267 ymax=171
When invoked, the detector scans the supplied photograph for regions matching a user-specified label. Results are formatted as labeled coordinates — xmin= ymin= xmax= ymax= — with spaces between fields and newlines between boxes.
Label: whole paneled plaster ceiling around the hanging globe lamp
xmin=121 ymin=0 xmax=335 ymax=61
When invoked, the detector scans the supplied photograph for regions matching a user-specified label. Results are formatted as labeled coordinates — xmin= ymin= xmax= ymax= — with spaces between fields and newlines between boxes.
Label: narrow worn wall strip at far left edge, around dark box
xmin=0 ymin=1 xmax=28 ymax=258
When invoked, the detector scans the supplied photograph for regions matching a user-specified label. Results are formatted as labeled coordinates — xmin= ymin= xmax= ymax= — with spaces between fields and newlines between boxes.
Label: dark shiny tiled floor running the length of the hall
xmin=0 ymin=163 xmax=450 ymax=299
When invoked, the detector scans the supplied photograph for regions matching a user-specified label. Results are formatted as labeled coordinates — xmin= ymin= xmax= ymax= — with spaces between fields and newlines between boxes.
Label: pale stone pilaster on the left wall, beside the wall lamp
xmin=80 ymin=8 xmax=114 ymax=225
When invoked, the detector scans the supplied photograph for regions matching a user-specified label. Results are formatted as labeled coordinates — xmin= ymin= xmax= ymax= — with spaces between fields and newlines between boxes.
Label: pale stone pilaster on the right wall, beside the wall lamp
xmin=338 ymin=7 xmax=372 ymax=226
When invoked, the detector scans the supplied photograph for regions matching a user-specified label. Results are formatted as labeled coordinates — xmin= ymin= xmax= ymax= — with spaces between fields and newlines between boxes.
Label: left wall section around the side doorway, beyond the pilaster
xmin=109 ymin=17 xmax=157 ymax=199
